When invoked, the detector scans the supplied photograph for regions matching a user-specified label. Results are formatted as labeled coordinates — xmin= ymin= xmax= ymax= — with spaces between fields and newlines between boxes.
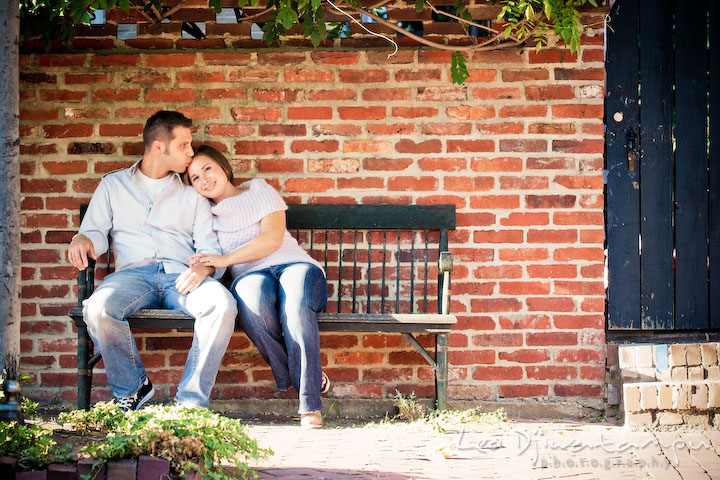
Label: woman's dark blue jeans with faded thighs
xmin=230 ymin=263 xmax=327 ymax=413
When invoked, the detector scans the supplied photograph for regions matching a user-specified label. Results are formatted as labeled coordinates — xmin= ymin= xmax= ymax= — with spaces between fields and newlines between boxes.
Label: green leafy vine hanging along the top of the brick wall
xmin=20 ymin=0 xmax=598 ymax=84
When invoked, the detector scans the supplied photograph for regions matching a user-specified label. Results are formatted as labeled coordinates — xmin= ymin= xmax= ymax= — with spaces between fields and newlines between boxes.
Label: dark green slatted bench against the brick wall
xmin=69 ymin=204 xmax=457 ymax=409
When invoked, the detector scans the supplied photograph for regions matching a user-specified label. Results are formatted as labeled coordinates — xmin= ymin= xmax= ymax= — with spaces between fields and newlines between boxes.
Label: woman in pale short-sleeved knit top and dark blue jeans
xmin=187 ymin=145 xmax=330 ymax=428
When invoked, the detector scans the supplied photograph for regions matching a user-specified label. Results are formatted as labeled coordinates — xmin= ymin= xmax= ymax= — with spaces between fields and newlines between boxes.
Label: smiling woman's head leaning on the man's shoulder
xmin=185 ymin=145 xmax=235 ymax=202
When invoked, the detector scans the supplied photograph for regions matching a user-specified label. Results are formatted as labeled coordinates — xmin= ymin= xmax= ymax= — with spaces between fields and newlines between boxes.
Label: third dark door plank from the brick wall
xmin=675 ymin=0 xmax=708 ymax=329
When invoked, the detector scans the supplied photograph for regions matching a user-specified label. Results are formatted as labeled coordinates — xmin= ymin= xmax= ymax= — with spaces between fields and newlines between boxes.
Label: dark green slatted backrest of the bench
xmin=78 ymin=204 xmax=455 ymax=313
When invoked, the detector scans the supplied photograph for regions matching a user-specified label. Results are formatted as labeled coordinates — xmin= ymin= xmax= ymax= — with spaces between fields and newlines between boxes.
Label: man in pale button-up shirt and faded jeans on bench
xmin=68 ymin=111 xmax=237 ymax=410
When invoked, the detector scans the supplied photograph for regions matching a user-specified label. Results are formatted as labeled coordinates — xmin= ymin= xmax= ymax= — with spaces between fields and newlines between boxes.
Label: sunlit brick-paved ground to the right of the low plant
xmin=243 ymin=419 xmax=720 ymax=480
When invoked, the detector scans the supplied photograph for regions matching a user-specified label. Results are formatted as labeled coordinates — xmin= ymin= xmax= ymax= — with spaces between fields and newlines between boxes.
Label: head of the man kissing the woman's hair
xmin=143 ymin=110 xmax=193 ymax=173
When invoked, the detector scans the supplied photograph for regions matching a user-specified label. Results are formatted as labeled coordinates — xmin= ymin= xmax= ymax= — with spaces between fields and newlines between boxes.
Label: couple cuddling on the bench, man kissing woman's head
xmin=68 ymin=111 xmax=329 ymax=428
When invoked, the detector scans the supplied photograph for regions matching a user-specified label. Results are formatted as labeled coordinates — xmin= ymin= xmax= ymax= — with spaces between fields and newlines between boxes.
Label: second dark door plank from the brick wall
xmin=640 ymin=0 xmax=674 ymax=329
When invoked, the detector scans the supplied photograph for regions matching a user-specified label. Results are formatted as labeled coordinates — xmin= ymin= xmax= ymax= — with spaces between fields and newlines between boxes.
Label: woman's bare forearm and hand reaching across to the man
xmin=190 ymin=210 xmax=285 ymax=268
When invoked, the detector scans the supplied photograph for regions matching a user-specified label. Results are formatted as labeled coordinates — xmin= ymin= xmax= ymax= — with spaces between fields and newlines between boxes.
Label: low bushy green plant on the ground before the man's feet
xmin=58 ymin=402 xmax=273 ymax=480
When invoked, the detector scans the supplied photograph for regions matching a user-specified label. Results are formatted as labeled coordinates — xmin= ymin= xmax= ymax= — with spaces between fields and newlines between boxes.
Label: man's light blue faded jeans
xmin=83 ymin=263 xmax=237 ymax=407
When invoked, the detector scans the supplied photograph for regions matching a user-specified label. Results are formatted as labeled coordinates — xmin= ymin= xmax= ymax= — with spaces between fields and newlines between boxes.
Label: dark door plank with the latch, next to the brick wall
xmin=605 ymin=2 xmax=640 ymax=329
